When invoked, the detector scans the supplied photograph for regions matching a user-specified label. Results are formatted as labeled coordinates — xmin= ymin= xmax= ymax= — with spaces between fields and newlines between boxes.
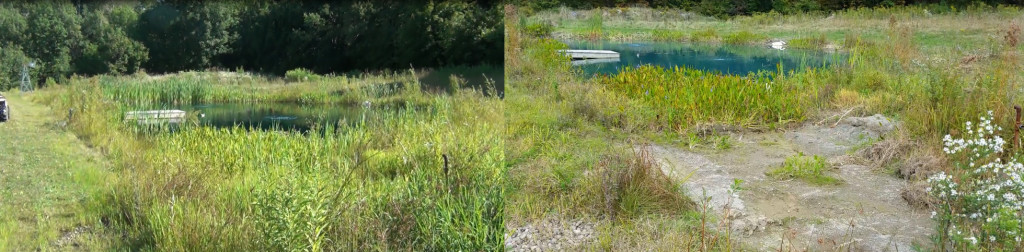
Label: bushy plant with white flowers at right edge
xmin=927 ymin=112 xmax=1024 ymax=248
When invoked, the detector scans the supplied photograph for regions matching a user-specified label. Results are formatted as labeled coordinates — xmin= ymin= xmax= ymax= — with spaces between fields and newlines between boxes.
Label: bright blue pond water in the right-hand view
xmin=563 ymin=41 xmax=846 ymax=76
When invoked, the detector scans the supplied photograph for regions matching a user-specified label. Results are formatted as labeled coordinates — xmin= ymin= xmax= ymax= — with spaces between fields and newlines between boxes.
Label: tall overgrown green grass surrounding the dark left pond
xmin=39 ymin=68 xmax=505 ymax=251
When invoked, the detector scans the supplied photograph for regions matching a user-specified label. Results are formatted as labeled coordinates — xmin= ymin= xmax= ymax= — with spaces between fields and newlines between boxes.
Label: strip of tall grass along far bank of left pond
xmin=99 ymin=68 xmax=440 ymax=108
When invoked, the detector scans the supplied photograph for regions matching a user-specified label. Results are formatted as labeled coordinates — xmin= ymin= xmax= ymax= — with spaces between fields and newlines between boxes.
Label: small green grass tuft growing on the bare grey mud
xmin=765 ymin=153 xmax=843 ymax=185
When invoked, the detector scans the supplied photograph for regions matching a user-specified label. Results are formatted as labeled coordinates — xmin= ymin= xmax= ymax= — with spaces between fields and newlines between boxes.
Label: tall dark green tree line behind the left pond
xmin=0 ymin=0 xmax=504 ymax=90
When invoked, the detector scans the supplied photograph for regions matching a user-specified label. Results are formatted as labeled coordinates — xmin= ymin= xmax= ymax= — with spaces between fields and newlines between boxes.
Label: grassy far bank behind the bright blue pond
xmin=521 ymin=6 xmax=1022 ymax=53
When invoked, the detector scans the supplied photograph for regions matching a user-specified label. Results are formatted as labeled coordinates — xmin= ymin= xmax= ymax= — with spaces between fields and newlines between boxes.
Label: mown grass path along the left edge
xmin=0 ymin=93 xmax=110 ymax=251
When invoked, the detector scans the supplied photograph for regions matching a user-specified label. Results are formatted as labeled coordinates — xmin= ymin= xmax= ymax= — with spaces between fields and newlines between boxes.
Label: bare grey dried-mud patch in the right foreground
xmin=646 ymin=117 xmax=934 ymax=251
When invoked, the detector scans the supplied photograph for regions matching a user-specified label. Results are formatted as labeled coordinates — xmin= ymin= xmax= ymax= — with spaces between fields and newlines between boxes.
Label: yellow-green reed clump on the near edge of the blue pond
xmin=601 ymin=66 xmax=808 ymax=128
